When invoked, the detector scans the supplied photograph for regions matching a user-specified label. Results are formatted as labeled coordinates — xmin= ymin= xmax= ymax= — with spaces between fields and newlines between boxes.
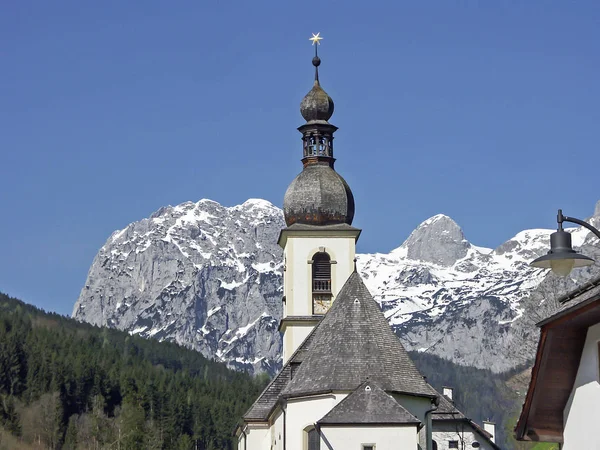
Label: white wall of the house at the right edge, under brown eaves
xmin=563 ymin=324 xmax=600 ymax=450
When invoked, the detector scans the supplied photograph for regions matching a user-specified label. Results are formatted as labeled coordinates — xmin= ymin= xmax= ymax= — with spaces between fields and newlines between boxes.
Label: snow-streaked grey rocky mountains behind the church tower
xmin=73 ymin=200 xmax=600 ymax=373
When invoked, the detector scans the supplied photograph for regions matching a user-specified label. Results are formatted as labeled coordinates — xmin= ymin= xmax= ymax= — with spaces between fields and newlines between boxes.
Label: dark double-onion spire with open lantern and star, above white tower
xmin=283 ymin=34 xmax=354 ymax=226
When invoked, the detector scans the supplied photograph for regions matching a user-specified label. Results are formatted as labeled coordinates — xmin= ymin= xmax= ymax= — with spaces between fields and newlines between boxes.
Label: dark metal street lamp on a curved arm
xmin=530 ymin=209 xmax=600 ymax=277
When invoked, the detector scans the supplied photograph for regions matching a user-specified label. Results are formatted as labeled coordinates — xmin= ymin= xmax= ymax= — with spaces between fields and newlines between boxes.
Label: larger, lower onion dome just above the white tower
xmin=283 ymin=164 xmax=354 ymax=226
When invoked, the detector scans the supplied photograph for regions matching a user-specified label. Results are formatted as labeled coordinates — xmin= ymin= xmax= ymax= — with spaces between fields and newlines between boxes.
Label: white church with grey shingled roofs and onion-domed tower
xmin=235 ymin=34 xmax=499 ymax=450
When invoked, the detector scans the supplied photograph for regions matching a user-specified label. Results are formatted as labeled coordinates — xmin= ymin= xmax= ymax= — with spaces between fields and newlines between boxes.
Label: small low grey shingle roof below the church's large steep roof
xmin=317 ymin=381 xmax=421 ymax=425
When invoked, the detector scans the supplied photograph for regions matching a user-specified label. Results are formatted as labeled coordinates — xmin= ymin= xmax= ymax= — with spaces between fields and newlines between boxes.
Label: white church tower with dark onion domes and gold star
xmin=279 ymin=35 xmax=360 ymax=364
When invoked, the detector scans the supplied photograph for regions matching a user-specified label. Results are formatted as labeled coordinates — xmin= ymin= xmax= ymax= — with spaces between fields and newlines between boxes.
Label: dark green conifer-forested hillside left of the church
xmin=0 ymin=294 xmax=266 ymax=450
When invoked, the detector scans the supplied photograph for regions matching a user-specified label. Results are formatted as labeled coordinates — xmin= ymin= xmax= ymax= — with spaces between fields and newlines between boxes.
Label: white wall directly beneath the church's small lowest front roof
xmin=321 ymin=425 xmax=417 ymax=450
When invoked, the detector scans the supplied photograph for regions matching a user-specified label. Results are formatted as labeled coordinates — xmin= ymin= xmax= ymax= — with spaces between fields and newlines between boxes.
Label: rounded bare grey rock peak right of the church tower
xmin=402 ymin=214 xmax=471 ymax=266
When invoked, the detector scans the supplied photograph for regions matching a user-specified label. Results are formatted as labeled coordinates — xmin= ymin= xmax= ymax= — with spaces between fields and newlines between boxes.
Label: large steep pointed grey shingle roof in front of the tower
xmin=281 ymin=272 xmax=438 ymax=398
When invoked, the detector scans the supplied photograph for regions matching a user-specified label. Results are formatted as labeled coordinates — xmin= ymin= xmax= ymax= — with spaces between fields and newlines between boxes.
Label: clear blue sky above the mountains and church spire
xmin=0 ymin=0 xmax=600 ymax=313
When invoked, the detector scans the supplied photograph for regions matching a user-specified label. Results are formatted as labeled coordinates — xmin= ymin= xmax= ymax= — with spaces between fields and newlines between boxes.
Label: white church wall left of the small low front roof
xmin=285 ymin=393 xmax=348 ymax=450
